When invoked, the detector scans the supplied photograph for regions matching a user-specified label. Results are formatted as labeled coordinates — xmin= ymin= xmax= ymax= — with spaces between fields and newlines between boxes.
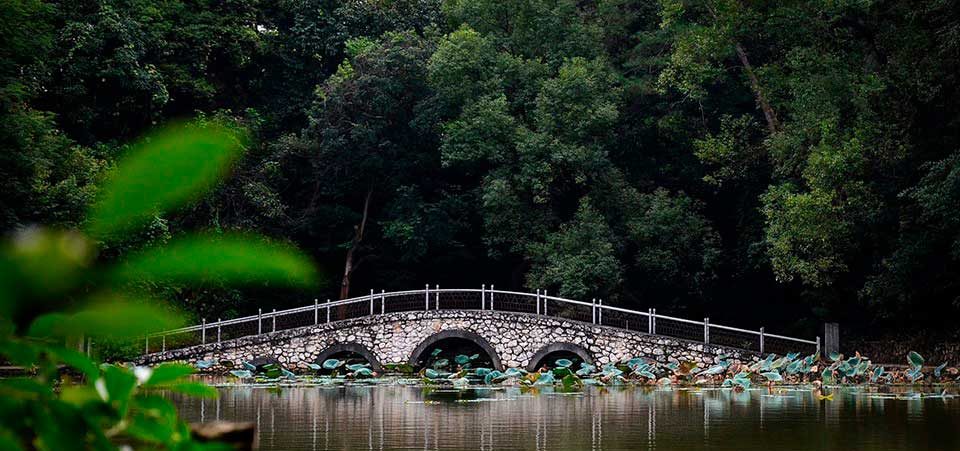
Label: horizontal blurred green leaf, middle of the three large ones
xmin=112 ymin=234 xmax=318 ymax=286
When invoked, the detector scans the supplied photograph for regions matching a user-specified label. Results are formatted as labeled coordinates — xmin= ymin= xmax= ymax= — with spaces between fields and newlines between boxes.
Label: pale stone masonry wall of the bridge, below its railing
xmin=138 ymin=310 xmax=757 ymax=372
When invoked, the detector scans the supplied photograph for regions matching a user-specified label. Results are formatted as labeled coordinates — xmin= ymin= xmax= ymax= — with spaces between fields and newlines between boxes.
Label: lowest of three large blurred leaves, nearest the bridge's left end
xmin=28 ymin=297 xmax=183 ymax=338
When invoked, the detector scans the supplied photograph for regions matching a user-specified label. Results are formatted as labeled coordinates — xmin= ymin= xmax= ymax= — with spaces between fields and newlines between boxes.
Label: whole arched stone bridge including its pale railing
xmin=140 ymin=286 xmax=820 ymax=369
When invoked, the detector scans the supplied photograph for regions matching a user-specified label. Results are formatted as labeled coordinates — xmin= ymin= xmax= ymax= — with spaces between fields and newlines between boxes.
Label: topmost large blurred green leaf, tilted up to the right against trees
xmin=87 ymin=125 xmax=242 ymax=239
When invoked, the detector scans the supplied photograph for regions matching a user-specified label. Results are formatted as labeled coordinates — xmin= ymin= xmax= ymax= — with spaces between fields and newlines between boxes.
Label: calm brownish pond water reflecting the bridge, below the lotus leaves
xmin=174 ymin=386 xmax=960 ymax=451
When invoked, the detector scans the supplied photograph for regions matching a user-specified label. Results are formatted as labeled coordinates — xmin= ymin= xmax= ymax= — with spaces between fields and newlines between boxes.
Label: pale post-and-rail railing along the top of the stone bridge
xmin=144 ymin=285 xmax=820 ymax=354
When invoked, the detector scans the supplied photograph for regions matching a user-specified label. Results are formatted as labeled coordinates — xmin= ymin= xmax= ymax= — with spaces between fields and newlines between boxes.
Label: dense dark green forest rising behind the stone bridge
xmin=0 ymin=0 xmax=960 ymax=339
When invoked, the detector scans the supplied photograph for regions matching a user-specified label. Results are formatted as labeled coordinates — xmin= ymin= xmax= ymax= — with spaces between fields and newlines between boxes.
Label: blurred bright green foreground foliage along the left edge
xmin=0 ymin=122 xmax=317 ymax=450
